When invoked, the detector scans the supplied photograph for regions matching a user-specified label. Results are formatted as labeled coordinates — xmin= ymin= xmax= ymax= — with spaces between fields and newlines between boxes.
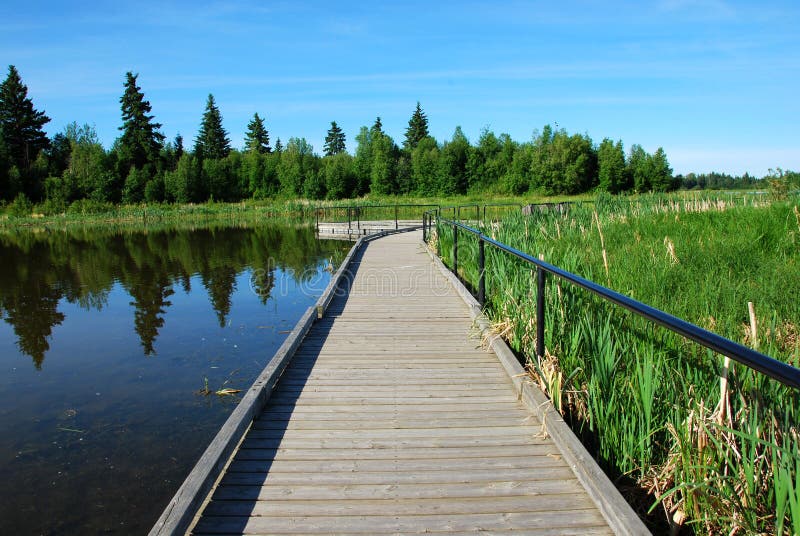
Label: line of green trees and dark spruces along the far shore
xmin=0 ymin=65 xmax=788 ymax=210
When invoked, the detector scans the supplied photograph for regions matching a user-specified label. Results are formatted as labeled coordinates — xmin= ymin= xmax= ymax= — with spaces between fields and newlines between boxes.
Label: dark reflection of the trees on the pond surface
xmin=0 ymin=227 xmax=342 ymax=368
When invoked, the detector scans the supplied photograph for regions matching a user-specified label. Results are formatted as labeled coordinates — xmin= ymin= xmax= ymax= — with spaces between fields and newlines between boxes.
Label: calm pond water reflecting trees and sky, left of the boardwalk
xmin=0 ymin=222 xmax=349 ymax=534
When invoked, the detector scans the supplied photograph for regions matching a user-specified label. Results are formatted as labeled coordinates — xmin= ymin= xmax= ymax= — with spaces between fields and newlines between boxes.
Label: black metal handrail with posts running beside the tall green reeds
xmin=432 ymin=211 xmax=800 ymax=389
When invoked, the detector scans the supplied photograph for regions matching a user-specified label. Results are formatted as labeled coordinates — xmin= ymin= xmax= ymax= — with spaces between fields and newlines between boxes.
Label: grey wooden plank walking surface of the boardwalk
xmin=193 ymin=232 xmax=612 ymax=534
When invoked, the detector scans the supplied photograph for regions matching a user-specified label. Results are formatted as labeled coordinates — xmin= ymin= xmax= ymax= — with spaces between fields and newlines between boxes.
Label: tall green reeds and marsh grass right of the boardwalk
xmin=434 ymin=197 xmax=800 ymax=534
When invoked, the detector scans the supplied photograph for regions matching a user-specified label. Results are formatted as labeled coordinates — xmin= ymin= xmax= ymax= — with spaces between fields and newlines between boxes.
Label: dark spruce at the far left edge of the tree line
xmin=0 ymin=65 xmax=50 ymax=177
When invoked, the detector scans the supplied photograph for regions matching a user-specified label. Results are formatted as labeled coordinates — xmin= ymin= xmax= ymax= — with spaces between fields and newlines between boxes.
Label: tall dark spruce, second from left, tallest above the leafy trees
xmin=118 ymin=71 xmax=164 ymax=177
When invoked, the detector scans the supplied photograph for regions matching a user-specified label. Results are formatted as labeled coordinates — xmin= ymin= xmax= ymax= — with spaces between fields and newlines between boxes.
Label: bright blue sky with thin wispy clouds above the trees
xmin=0 ymin=0 xmax=800 ymax=175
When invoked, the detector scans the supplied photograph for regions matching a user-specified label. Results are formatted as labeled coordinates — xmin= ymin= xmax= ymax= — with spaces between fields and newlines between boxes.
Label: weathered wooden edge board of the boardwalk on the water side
xmin=149 ymin=226 xmax=419 ymax=536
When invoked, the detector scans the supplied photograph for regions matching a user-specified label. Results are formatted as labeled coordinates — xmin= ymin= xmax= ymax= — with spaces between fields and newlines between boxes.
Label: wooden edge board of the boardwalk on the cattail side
xmin=421 ymin=242 xmax=651 ymax=535
